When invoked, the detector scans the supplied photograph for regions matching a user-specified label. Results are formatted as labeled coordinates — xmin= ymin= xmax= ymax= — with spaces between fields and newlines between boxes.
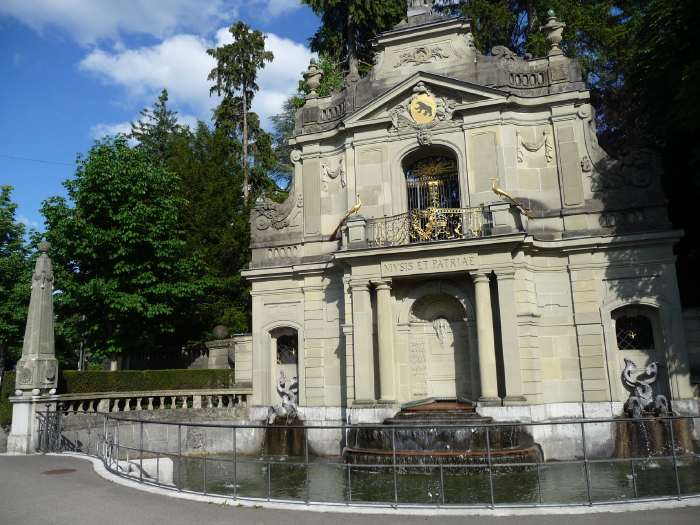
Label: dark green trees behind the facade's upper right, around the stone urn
xmin=440 ymin=0 xmax=647 ymax=152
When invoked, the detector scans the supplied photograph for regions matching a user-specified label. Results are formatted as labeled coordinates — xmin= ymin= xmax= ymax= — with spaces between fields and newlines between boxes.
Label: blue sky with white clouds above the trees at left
xmin=0 ymin=0 xmax=318 ymax=230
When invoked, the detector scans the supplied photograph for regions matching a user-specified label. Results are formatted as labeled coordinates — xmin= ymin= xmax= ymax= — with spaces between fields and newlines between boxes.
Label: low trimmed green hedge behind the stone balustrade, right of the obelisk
xmin=58 ymin=369 xmax=234 ymax=394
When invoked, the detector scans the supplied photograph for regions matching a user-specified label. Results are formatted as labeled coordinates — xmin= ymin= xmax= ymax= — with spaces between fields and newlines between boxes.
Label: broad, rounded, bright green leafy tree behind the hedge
xmin=42 ymin=136 xmax=204 ymax=364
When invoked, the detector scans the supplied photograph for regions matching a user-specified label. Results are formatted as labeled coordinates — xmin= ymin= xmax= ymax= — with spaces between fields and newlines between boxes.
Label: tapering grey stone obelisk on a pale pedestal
xmin=7 ymin=242 xmax=58 ymax=454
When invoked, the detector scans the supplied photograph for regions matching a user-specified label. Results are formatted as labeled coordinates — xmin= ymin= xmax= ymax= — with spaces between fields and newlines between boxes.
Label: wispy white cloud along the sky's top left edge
xmin=0 ymin=0 xmax=234 ymax=44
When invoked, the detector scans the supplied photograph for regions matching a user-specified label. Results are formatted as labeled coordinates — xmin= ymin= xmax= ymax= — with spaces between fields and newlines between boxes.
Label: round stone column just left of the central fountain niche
xmin=375 ymin=281 xmax=396 ymax=403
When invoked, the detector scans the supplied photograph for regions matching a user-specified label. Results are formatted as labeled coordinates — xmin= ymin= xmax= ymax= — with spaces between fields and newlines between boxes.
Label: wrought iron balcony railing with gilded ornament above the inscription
xmin=367 ymin=206 xmax=493 ymax=247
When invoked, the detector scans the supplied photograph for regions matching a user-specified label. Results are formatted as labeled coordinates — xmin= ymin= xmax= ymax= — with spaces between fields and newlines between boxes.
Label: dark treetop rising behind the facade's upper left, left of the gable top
xmin=302 ymin=0 xmax=406 ymax=78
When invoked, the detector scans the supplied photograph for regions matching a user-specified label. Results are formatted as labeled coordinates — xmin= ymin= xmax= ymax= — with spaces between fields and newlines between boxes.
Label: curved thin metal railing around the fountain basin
xmin=39 ymin=413 xmax=700 ymax=508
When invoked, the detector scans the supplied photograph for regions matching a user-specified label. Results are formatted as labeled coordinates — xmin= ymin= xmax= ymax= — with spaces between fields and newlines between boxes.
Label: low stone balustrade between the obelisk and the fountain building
xmin=52 ymin=384 xmax=253 ymax=414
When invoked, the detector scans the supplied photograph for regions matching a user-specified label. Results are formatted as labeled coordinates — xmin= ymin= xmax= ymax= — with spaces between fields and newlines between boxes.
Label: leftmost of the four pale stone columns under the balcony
xmin=350 ymin=279 xmax=375 ymax=404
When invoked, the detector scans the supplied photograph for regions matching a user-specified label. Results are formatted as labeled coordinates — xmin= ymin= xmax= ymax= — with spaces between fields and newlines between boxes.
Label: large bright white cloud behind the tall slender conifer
xmin=80 ymin=28 xmax=312 ymax=129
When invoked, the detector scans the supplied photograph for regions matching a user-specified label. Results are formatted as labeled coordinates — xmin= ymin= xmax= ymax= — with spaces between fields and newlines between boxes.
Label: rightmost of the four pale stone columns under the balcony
xmin=496 ymin=268 xmax=525 ymax=405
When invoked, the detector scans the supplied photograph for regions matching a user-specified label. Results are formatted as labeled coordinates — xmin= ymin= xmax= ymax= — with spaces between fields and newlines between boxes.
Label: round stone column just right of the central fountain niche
xmin=472 ymin=271 xmax=500 ymax=405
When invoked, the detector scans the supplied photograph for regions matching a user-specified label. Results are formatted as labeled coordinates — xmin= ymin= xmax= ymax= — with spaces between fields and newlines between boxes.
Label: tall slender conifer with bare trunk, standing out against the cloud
xmin=207 ymin=22 xmax=274 ymax=203
